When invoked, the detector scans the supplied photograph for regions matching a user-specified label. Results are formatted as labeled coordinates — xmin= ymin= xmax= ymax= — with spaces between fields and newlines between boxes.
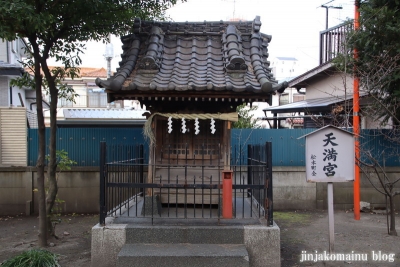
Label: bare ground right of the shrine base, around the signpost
xmin=275 ymin=211 xmax=400 ymax=267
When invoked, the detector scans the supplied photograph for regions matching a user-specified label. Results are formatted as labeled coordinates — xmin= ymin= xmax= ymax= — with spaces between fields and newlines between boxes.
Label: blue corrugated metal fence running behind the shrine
xmin=28 ymin=128 xmax=400 ymax=166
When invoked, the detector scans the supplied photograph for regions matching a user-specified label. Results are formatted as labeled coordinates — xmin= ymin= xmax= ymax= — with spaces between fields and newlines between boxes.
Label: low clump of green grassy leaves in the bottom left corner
xmin=1 ymin=249 xmax=60 ymax=267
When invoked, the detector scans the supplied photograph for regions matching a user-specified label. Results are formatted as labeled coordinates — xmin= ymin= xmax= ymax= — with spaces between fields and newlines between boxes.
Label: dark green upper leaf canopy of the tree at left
xmin=0 ymin=0 xmax=176 ymax=41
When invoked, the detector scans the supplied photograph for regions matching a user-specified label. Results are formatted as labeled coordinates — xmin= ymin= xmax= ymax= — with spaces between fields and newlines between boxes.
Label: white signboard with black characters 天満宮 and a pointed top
xmin=304 ymin=126 xmax=355 ymax=182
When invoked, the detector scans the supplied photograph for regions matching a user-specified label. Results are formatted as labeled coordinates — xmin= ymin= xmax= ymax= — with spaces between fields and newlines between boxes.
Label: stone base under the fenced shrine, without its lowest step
xmin=91 ymin=223 xmax=281 ymax=267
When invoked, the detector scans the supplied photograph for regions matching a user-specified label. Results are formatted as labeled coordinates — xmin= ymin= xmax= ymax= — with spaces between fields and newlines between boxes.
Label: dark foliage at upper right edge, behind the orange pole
xmin=335 ymin=0 xmax=400 ymax=125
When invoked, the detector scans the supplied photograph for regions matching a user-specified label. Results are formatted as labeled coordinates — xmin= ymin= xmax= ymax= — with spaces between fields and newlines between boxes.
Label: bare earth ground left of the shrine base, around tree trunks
xmin=0 ymin=214 xmax=98 ymax=267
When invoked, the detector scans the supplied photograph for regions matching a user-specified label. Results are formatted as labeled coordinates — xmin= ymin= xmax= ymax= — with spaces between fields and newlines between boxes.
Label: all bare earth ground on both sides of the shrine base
xmin=0 ymin=210 xmax=400 ymax=267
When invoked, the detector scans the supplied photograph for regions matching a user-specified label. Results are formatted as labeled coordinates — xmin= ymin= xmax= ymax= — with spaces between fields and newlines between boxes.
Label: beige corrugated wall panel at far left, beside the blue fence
xmin=0 ymin=107 xmax=28 ymax=166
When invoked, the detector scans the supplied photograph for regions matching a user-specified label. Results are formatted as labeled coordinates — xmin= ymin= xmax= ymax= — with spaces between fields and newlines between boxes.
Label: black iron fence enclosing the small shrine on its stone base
xmin=100 ymin=142 xmax=273 ymax=225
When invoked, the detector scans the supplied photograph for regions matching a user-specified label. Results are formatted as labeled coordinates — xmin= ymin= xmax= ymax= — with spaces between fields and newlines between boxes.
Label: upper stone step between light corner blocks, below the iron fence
xmin=125 ymin=225 xmax=244 ymax=244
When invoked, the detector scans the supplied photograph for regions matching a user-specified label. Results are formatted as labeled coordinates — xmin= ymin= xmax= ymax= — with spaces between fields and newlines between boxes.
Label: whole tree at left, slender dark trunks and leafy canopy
xmin=0 ymin=0 xmax=181 ymax=246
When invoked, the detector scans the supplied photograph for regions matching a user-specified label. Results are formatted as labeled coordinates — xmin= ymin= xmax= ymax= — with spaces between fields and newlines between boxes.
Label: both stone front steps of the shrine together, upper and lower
xmin=117 ymin=225 xmax=249 ymax=267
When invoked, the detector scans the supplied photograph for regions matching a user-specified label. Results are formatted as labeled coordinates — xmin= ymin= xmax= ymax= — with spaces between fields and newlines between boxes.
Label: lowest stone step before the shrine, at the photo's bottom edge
xmin=117 ymin=243 xmax=249 ymax=267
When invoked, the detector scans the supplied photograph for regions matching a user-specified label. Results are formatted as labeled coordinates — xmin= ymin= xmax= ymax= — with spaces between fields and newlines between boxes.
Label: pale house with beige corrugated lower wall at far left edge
xmin=0 ymin=38 xmax=31 ymax=166
